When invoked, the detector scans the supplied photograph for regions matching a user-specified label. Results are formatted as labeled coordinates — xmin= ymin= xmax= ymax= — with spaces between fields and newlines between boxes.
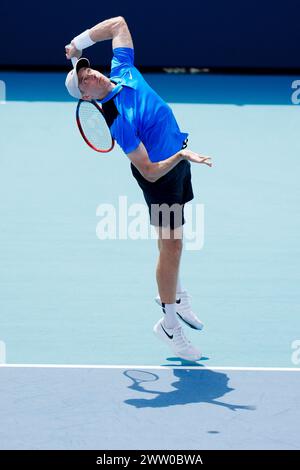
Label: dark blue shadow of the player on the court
xmin=124 ymin=369 xmax=255 ymax=411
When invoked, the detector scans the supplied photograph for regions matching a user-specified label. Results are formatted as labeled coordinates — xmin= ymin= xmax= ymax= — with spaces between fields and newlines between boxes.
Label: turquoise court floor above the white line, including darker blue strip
xmin=0 ymin=73 xmax=300 ymax=367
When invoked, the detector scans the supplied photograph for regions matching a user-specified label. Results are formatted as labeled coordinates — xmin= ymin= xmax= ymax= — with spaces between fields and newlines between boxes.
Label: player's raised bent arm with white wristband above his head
xmin=66 ymin=16 xmax=133 ymax=59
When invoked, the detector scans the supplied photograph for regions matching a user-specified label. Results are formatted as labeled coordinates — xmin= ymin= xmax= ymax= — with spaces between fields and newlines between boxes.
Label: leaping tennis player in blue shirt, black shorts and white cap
xmin=65 ymin=17 xmax=212 ymax=361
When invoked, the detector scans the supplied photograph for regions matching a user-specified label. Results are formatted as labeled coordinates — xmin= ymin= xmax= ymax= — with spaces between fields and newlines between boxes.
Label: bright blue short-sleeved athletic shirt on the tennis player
xmin=110 ymin=47 xmax=188 ymax=162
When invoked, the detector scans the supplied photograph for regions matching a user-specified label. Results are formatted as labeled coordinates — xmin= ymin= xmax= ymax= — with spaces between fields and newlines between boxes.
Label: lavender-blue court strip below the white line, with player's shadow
xmin=0 ymin=367 xmax=300 ymax=450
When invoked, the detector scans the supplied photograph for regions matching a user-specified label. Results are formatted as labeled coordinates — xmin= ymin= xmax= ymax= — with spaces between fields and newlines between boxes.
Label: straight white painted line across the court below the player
xmin=0 ymin=364 xmax=300 ymax=372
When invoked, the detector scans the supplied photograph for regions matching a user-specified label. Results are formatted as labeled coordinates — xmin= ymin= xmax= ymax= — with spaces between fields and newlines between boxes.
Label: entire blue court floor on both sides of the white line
xmin=0 ymin=73 xmax=300 ymax=449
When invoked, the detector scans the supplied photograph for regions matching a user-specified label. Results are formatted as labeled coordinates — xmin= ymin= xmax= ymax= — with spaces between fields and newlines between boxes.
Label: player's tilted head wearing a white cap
xmin=66 ymin=57 xmax=110 ymax=100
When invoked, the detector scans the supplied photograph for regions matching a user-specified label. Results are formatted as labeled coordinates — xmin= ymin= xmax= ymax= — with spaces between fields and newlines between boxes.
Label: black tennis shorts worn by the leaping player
xmin=131 ymin=143 xmax=194 ymax=230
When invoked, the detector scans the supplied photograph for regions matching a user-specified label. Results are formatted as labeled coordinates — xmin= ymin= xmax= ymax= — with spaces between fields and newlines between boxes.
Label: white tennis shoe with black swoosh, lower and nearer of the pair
xmin=153 ymin=318 xmax=202 ymax=361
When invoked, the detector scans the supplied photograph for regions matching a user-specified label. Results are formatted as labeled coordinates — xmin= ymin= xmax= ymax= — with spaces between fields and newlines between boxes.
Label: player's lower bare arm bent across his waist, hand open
xmin=127 ymin=142 xmax=212 ymax=183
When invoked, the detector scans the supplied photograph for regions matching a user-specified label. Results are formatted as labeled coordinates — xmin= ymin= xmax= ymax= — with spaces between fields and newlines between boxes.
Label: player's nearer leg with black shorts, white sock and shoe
xmin=131 ymin=161 xmax=201 ymax=361
